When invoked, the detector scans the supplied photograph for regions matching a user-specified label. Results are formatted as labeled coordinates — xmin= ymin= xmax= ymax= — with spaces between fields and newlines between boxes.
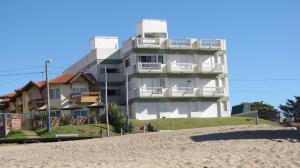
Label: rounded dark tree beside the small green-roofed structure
xmin=251 ymin=101 xmax=279 ymax=121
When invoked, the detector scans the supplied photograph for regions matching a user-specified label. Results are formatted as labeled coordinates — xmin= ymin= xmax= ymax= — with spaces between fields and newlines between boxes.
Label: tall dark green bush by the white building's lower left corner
xmin=101 ymin=104 xmax=126 ymax=132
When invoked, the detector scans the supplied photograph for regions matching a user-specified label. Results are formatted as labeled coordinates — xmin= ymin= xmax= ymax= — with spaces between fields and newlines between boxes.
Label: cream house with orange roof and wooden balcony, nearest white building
xmin=43 ymin=73 xmax=100 ymax=116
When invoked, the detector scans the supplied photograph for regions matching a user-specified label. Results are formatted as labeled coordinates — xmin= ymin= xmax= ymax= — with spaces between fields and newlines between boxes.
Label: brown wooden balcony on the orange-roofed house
xmin=71 ymin=92 xmax=100 ymax=104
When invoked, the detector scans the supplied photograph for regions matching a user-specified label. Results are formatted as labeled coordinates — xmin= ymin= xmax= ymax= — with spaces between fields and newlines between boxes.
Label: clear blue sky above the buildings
xmin=0 ymin=0 xmax=300 ymax=106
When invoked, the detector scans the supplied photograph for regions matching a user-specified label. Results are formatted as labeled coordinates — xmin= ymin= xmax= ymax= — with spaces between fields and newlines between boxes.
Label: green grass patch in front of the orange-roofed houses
xmin=34 ymin=124 xmax=118 ymax=138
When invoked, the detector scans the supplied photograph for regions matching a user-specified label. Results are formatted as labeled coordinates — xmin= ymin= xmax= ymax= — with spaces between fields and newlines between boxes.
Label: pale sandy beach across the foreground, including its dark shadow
xmin=0 ymin=126 xmax=300 ymax=168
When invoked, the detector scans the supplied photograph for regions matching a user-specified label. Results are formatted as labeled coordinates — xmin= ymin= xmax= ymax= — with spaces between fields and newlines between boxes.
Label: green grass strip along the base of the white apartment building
xmin=131 ymin=117 xmax=276 ymax=133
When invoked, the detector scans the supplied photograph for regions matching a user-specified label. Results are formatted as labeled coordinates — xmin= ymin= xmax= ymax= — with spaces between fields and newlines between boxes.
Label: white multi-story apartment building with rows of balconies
xmin=66 ymin=19 xmax=230 ymax=119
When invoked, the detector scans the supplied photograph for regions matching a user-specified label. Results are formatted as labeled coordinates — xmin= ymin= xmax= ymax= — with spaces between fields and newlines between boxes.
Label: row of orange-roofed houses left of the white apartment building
xmin=0 ymin=73 xmax=100 ymax=116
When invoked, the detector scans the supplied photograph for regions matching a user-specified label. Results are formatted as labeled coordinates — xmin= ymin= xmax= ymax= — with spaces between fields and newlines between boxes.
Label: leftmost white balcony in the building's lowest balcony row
xmin=136 ymin=87 xmax=167 ymax=97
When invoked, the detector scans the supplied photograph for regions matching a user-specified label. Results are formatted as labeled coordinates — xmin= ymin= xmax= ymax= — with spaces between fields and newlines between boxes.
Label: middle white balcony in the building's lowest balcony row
xmin=170 ymin=87 xmax=197 ymax=97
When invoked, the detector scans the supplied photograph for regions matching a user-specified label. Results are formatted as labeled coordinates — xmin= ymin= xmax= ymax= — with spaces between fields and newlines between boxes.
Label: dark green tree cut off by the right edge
xmin=279 ymin=96 xmax=300 ymax=122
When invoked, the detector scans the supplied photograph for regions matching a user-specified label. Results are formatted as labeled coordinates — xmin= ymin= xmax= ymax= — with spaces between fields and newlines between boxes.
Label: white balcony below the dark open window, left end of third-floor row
xmin=135 ymin=62 xmax=166 ymax=73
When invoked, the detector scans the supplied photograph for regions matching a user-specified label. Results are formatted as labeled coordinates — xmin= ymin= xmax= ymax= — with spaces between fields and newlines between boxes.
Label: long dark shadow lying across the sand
xmin=191 ymin=130 xmax=300 ymax=142
